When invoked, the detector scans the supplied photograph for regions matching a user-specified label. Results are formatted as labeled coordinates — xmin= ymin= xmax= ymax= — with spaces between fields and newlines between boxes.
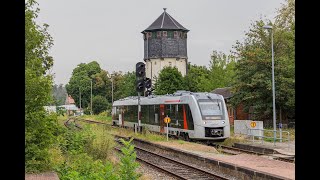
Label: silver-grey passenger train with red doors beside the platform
xmin=112 ymin=91 xmax=230 ymax=141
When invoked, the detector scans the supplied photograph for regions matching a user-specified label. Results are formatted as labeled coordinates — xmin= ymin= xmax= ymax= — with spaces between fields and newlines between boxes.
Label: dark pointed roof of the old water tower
xmin=142 ymin=8 xmax=189 ymax=33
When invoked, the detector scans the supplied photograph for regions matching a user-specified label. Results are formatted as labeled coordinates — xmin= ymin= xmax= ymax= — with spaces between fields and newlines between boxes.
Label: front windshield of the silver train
xmin=199 ymin=100 xmax=224 ymax=120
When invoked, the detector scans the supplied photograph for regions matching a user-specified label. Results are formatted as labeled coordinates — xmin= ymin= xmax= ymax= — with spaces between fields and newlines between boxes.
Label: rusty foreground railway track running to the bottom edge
xmin=116 ymin=140 xmax=227 ymax=180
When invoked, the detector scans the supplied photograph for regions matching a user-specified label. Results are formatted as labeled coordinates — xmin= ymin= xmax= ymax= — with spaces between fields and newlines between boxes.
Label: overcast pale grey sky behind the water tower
xmin=36 ymin=0 xmax=284 ymax=84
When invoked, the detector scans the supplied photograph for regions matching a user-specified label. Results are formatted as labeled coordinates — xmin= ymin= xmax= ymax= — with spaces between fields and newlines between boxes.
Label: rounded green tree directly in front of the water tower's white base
xmin=155 ymin=66 xmax=185 ymax=95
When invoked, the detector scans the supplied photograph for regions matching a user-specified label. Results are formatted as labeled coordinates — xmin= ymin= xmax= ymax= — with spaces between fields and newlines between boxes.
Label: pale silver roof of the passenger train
xmin=113 ymin=91 xmax=224 ymax=106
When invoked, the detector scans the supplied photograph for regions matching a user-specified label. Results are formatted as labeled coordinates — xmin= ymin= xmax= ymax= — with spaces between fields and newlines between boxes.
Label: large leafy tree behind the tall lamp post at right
xmin=232 ymin=0 xmax=295 ymax=120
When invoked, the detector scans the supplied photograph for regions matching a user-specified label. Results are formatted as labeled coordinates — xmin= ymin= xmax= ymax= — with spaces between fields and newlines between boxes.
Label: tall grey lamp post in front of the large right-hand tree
xmin=263 ymin=25 xmax=276 ymax=145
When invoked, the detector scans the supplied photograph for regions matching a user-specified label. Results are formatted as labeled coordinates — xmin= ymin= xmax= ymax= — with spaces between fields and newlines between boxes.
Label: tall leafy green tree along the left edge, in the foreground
xmin=25 ymin=0 xmax=58 ymax=172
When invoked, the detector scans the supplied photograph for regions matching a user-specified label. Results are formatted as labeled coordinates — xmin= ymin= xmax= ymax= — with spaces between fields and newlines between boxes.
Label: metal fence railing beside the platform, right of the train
xmin=247 ymin=128 xmax=290 ymax=149
